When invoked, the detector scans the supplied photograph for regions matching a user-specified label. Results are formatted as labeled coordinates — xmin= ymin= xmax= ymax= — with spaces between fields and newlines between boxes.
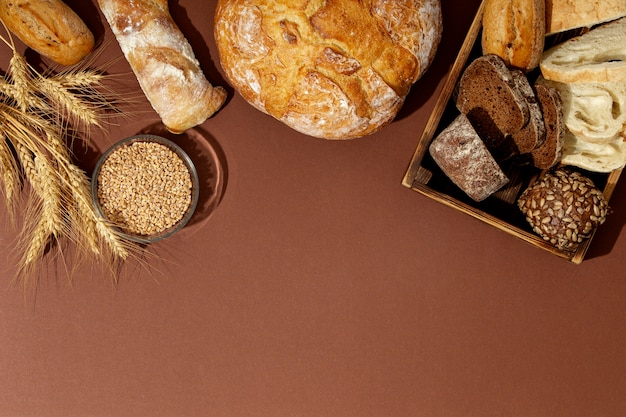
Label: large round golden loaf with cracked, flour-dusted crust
xmin=215 ymin=0 xmax=442 ymax=139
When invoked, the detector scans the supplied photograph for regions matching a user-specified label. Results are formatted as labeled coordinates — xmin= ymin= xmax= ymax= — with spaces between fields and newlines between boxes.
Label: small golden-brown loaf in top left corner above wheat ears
xmin=0 ymin=0 xmax=94 ymax=65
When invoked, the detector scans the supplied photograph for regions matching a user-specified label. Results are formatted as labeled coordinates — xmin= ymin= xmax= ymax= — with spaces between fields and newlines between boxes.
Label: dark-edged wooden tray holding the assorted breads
xmin=402 ymin=1 xmax=622 ymax=264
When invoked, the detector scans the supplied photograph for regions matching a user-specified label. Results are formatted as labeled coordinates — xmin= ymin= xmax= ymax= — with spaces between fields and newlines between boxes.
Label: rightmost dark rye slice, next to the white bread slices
xmin=531 ymin=84 xmax=565 ymax=169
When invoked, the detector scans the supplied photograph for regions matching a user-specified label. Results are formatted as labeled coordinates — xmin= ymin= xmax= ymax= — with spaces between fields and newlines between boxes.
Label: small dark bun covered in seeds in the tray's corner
xmin=518 ymin=168 xmax=609 ymax=250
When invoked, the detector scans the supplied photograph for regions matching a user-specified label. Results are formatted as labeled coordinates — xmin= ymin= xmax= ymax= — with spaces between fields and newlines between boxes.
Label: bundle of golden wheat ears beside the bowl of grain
xmin=0 ymin=36 xmax=138 ymax=282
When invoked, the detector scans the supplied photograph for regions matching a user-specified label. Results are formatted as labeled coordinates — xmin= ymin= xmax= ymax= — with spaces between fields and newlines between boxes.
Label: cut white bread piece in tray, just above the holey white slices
xmin=540 ymin=18 xmax=626 ymax=83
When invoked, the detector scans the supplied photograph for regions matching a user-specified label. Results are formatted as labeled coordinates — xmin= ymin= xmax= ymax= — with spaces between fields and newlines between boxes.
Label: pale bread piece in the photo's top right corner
xmin=545 ymin=0 xmax=626 ymax=35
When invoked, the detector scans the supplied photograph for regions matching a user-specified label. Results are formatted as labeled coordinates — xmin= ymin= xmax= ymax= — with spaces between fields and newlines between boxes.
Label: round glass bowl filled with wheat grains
xmin=92 ymin=135 xmax=198 ymax=243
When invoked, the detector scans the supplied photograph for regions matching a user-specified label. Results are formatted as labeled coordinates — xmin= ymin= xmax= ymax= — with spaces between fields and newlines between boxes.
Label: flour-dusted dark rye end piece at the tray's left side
xmin=429 ymin=114 xmax=509 ymax=201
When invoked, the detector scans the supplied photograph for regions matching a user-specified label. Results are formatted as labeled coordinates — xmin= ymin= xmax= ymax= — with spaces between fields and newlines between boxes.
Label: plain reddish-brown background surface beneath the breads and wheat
xmin=0 ymin=0 xmax=626 ymax=417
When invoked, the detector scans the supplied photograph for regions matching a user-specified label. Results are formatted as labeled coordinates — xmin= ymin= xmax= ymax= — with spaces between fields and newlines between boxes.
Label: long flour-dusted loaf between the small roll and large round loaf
xmin=98 ymin=0 xmax=226 ymax=133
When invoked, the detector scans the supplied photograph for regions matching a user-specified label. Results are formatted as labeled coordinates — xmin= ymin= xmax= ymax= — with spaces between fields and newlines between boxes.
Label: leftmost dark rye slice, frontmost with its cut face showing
xmin=456 ymin=55 xmax=529 ymax=148
